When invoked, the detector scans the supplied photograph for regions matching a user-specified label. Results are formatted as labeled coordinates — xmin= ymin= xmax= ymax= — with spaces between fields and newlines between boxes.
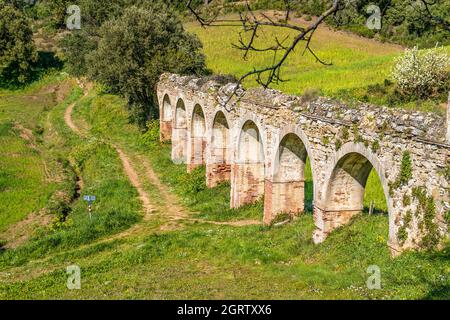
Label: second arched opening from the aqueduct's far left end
xmin=172 ymin=99 xmax=188 ymax=163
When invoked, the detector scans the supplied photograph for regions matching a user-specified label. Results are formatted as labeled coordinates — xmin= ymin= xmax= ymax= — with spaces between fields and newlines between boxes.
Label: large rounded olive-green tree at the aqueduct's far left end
xmin=87 ymin=2 xmax=204 ymax=125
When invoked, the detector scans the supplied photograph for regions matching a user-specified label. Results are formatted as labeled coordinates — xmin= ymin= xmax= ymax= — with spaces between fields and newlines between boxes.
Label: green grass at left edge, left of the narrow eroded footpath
xmin=0 ymin=75 xmax=64 ymax=232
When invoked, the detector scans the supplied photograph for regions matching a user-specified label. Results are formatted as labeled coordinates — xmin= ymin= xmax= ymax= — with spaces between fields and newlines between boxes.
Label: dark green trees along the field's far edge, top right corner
xmin=294 ymin=0 xmax=450 ymax=47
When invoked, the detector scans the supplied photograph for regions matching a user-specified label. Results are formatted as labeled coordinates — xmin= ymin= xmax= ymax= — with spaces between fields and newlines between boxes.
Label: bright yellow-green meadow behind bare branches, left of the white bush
xmin=186 ymin=17 xmax=402 ymax=94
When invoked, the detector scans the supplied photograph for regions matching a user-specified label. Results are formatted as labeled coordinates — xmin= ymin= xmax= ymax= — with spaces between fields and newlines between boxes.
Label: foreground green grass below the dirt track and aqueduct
xmin=0 ymin=212 xmax=449 ymax=299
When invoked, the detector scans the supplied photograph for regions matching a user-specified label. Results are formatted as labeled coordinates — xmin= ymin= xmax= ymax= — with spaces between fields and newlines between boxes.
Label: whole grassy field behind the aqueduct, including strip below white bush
xmin=185 ymin=16 xmax=450 ymax=113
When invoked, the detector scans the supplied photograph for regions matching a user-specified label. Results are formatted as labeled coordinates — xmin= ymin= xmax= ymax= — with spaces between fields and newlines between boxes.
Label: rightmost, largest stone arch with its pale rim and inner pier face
xmin=314 ymin=142 xmax=395 ymax=242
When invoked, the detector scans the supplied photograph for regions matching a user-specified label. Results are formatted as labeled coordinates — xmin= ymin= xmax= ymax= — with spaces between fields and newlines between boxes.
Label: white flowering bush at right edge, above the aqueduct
xmin=392 ymin=47 xmax=450 ymax=98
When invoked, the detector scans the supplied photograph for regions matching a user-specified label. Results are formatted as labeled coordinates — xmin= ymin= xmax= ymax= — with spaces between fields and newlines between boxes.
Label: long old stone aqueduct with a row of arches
xmin=157 ymin=74 xmax=449 ymax=254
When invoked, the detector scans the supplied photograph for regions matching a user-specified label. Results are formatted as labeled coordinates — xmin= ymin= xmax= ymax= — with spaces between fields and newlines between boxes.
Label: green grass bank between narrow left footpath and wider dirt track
xmin=0 ymin=75 xmax=142 ymax=267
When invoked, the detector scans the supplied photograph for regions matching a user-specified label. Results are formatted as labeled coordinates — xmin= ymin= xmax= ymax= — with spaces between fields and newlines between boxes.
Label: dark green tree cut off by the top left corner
xmin=0 ymin=0 xmax=37 ymax=86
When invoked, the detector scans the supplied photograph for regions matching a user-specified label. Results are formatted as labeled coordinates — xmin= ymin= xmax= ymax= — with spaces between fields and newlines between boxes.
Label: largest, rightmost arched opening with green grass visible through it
xmin=323 ymin=152 xmax=388 ymax=238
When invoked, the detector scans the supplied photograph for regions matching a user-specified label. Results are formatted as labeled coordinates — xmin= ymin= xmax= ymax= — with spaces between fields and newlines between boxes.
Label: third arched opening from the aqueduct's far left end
xmin=188 ymin=104 xmax=206 ymax=171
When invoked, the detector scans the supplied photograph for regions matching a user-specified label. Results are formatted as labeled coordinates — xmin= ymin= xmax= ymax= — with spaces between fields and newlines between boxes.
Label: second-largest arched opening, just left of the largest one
xmin=264 ymin=133 xmax=312 ymax=223
